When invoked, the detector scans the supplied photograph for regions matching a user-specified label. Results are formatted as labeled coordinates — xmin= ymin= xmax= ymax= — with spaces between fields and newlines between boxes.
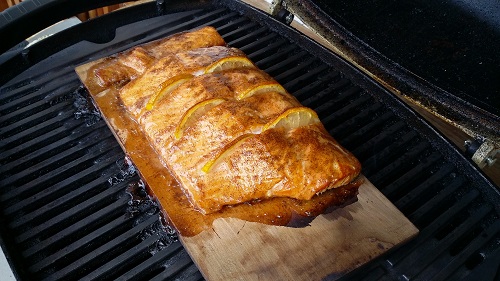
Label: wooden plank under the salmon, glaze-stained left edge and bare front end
xmin=76 ymin=40 xmax=418 ymax=280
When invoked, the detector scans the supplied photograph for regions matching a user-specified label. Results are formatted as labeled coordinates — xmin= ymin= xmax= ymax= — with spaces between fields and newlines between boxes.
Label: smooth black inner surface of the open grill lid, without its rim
xmin=311 ymin=0 xmax=500 ymax=116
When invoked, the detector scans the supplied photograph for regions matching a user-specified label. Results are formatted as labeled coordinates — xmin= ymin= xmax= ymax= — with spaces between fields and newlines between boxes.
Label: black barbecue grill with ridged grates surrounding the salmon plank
xmin=0 ymin=0 xmax=500 ymax=280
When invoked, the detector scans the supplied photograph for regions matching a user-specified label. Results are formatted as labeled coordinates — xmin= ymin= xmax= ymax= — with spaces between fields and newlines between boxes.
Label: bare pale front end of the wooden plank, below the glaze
xmin=181 ymin=176 xmax=418 ymax=280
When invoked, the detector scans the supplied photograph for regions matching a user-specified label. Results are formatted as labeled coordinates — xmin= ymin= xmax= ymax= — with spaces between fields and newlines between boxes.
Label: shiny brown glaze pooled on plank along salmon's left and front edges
xmin=85 ymin=84 xmax=361 ymax=236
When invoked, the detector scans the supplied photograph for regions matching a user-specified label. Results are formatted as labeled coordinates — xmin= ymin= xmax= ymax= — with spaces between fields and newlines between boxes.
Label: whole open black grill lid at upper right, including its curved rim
xmin=285 ymin=0 xmax=500 ymax=153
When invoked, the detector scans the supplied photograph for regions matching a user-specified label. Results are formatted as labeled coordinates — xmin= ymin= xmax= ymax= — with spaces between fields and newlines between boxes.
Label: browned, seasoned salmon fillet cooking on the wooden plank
xmin=94 ymin=29 xmax=361 ymax=214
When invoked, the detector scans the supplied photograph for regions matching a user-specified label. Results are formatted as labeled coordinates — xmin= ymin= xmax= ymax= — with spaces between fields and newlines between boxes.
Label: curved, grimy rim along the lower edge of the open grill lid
xmin=283 ymin=0 xmax=500 ymax=153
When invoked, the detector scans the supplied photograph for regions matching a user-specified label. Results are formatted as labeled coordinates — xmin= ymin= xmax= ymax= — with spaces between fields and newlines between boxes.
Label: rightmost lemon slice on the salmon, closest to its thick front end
xmin=262 ymin=107 xmax=320 ymax=131
